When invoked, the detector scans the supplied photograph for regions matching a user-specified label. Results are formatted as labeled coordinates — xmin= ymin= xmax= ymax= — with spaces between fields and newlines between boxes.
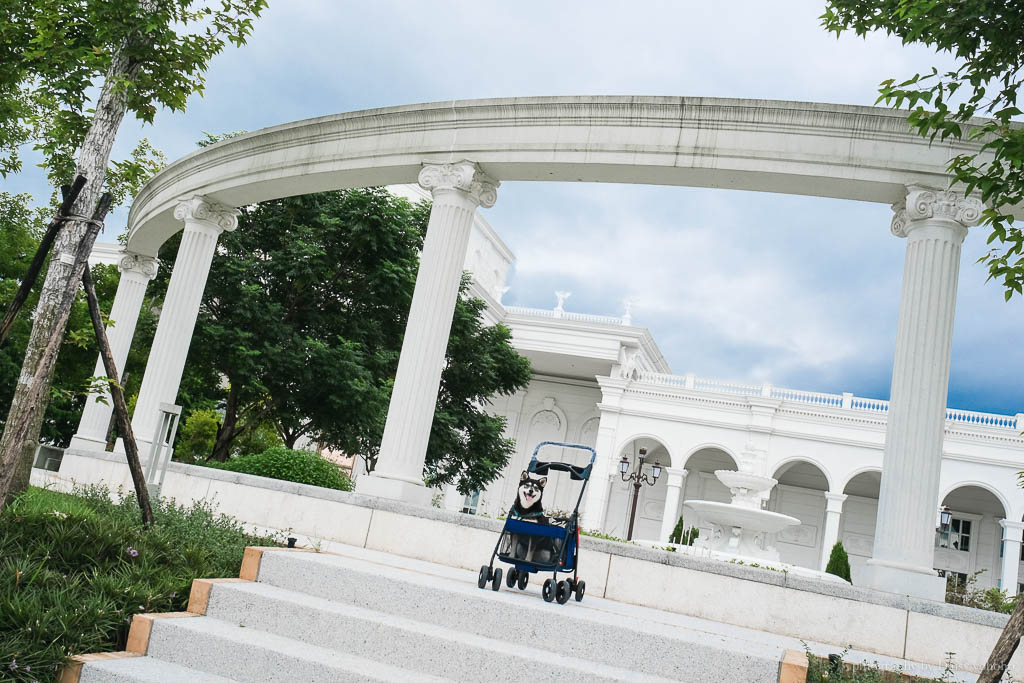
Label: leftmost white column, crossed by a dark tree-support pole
xmin=71 ymin=253 xmax=158 ymax=451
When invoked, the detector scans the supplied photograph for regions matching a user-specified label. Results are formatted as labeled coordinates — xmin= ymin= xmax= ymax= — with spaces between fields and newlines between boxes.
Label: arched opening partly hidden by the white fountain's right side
xmin=767 ymin=460 xmax=828 ymax=569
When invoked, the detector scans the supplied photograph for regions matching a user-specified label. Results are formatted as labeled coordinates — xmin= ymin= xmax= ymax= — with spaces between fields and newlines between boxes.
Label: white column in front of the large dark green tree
xmin=356 ymin=161 xmax=499 ymax=505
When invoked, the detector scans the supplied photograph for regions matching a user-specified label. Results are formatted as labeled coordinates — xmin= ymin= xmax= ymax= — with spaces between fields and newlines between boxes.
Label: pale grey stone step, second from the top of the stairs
xmin=206 ymin=583 xmax=667 ymax=683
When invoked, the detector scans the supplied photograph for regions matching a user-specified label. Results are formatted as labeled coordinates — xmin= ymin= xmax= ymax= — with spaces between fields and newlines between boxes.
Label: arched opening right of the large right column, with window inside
xmin=934 ymin=484 xmax=1007 ymax=593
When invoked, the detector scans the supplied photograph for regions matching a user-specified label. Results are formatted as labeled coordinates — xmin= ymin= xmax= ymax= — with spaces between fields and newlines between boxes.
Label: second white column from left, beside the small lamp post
xmin=125 ymin=197 xmax=239 ymax=459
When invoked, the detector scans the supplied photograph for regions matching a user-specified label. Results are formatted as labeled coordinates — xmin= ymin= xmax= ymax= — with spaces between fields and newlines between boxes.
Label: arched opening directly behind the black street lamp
xmin=604 ymin=436 xmax=672 ymax=541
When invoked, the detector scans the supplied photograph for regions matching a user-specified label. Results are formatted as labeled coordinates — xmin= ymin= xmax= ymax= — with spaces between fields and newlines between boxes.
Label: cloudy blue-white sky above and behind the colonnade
xmin=8 ymin=0 xmax=1024 ymax=415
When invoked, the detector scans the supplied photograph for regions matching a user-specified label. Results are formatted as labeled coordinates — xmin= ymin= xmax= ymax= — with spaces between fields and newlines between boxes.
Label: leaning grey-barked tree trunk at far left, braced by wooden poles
xmin=0 ymin=5 xmax=145 ymax=509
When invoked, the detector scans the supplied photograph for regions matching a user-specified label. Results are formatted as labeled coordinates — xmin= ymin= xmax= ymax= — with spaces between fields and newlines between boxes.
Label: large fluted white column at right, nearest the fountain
xmin=864 ymin=186 xmax=983 ymax=600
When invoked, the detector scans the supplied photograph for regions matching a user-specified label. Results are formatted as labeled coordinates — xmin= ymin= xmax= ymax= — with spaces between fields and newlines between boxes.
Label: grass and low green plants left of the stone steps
xmin=0 ymin=487 xmax=280 ymax=682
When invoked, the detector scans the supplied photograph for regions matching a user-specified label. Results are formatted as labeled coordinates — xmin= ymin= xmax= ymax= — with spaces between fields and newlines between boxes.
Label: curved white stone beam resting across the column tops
xmin=126 ymin=96 xmax=979 ymax=256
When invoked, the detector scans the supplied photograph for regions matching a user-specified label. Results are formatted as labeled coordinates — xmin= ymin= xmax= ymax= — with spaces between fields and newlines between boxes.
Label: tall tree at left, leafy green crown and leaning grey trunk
xmin=0 ymin=0 xmax=266 ymax=506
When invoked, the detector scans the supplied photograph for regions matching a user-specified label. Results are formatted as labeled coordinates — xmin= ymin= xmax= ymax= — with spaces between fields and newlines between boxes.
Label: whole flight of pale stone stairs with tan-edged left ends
xmin=62 ymin=549 xmax=781 ymax=683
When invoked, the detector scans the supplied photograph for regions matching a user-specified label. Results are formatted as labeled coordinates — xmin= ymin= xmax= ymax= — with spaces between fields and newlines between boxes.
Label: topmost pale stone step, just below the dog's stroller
xmin=247 ymin=551 xmax=784 ymax=683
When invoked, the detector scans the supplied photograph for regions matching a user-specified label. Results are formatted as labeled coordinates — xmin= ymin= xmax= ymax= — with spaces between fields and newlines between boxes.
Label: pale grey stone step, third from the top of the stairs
xmin=140 ymin=615 xmax=449 ymax=683
